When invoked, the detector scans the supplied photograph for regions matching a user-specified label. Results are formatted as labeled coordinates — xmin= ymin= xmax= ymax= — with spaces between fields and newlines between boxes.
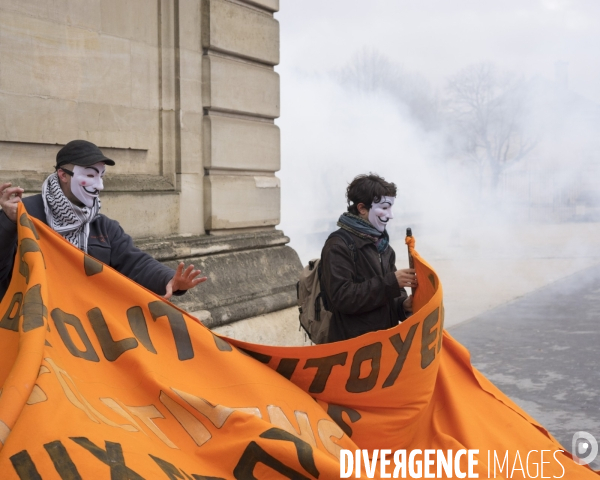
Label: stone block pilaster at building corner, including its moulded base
xmin=165 ymin=0 xmax=301 ymax=326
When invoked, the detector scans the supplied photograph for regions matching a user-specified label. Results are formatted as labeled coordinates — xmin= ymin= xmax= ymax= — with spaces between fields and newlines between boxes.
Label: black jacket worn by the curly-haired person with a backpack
xmin=321 ymin=228 xmax=407 ymax=342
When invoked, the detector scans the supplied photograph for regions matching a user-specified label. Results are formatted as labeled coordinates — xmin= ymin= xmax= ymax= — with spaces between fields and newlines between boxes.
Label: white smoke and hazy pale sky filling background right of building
xmin=277 ymin=0 xmax=600 ymax=324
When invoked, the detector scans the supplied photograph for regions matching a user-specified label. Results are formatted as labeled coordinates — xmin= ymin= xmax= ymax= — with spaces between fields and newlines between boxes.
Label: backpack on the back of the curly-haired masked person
xmin=296 ymin=228 xmax=358 ymax=344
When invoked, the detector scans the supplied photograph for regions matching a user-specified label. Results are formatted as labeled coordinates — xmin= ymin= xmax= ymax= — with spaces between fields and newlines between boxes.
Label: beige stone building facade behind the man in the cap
xmin=0 ymin=0 xmax=301 ymax=342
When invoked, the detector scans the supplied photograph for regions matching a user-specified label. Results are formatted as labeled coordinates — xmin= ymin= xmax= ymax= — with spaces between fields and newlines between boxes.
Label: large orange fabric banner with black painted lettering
xmin=0 ymin=204 xmax=598 ymax=480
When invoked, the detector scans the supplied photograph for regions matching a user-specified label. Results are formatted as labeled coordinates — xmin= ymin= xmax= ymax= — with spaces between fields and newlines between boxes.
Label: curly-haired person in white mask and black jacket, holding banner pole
xmin=321 ymin=174 xmax=417 ymax=342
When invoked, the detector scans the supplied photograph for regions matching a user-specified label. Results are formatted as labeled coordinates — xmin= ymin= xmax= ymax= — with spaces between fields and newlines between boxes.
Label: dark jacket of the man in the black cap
xmin=0 ymin=195 xmax=176 ymax=300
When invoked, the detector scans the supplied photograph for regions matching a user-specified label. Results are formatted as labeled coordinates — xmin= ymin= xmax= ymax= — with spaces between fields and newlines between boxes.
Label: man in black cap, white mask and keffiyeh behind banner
xmin=0 ymin=140 xmax=206 ymax=300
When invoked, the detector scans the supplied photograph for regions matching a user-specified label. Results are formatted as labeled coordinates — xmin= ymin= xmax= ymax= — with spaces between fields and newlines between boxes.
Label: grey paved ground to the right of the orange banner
xmin=449 ymin=266 xmax=600 ymax=469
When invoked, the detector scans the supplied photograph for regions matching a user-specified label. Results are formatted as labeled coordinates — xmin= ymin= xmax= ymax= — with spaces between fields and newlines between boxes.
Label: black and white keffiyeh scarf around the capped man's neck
xmin=42 ymin=172 xmax=100 ymax=253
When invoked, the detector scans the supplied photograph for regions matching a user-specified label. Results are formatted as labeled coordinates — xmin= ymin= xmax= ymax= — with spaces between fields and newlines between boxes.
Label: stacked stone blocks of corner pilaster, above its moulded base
xmin=202 ymin=0 xmax=280 ymax=234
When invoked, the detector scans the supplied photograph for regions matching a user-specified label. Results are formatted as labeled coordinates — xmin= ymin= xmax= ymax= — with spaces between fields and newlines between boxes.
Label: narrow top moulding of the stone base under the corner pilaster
xmin=136 ymin=230 xmax=290 ymax=262
